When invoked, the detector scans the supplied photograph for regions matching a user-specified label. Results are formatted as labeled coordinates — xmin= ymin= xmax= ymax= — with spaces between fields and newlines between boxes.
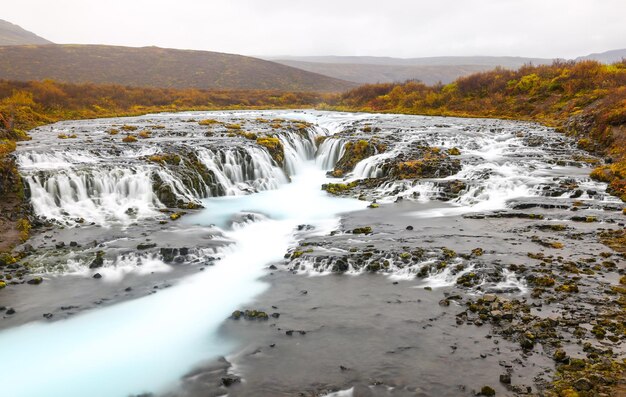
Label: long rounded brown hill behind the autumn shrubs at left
xmin=0 ymin=45 xmax=355 ymax=92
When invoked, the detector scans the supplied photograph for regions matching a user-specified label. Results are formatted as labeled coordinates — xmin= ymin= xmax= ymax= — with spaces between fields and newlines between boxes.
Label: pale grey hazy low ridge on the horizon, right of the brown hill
xmin=269 ymin=56 xmax=552 ymax=84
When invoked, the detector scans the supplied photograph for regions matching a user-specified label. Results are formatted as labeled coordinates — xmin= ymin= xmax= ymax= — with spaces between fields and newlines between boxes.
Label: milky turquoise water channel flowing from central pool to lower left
xmin=0 ymin=162 xmax=367 ymax=397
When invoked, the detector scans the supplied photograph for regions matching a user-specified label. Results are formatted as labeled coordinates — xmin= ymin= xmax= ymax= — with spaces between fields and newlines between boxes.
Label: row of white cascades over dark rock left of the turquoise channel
xmin=18 ymin=129 xmax=317 ymax=226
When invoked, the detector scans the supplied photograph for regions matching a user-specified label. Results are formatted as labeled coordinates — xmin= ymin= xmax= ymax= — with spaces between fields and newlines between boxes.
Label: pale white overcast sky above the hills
xmin=0 ymin=0 xmax=626 ymax=58
